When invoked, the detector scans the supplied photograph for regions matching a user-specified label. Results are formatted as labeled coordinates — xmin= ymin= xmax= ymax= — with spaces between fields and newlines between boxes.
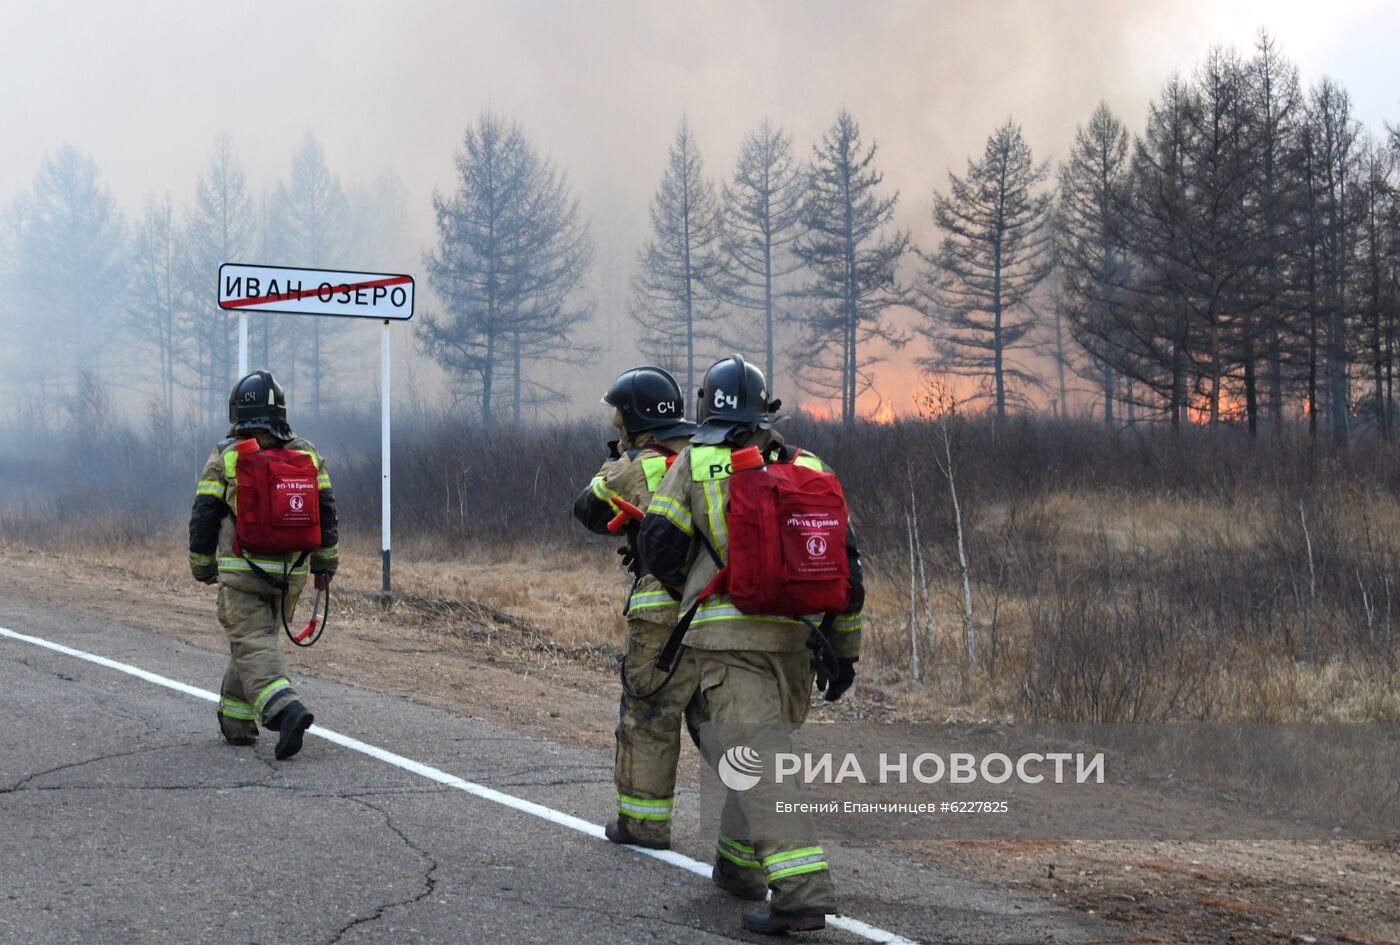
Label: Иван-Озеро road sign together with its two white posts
xmin=218 ymin=263 xmax=413 ymax=594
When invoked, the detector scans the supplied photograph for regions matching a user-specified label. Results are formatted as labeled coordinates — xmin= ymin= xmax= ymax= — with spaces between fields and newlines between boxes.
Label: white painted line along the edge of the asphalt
xmin=0 ymin=627 xmax=916 ymax=945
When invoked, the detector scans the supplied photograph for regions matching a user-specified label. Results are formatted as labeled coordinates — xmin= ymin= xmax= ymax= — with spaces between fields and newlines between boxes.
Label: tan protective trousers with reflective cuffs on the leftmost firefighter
xmin=218 ymin=581 xmax=302 ymax=739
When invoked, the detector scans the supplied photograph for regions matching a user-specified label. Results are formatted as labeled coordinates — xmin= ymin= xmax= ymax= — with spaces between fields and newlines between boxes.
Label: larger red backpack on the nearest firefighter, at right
xmin=701 ymin=447 xmax=851 ymax=617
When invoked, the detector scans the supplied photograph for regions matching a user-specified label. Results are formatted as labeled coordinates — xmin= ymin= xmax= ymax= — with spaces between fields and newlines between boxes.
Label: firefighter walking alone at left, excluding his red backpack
xmin=189 ymin=371 xmax=340 ymax=760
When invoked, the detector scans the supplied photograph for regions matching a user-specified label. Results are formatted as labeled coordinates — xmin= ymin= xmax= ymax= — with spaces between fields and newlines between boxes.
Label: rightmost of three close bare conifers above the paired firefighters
xmin=795 ymin=111 xmax=909 ymax=424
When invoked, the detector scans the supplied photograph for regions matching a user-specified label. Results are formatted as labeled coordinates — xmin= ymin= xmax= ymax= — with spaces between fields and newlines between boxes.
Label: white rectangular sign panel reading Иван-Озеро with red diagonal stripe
xmin=218 ymin=263 xmax=413 ymax=322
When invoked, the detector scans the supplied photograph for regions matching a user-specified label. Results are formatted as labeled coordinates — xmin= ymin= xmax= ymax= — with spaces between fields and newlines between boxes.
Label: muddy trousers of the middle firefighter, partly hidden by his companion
xmin=613 ymin=617 xmax=696 ymax=843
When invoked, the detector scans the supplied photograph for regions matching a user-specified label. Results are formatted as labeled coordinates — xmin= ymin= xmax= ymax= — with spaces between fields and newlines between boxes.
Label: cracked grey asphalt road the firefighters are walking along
xmin=0 ymin=599 xmax=1117 ymax=945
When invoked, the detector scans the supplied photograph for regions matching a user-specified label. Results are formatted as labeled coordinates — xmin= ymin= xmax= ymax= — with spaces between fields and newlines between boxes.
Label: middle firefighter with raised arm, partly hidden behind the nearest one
xmin=574 ymin=367 xmax=696 ymax=850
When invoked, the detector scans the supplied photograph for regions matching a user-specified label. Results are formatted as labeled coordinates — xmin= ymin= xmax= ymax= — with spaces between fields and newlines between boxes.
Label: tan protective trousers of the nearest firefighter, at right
xmin=686 ymin=650 xmax=836 ymax=913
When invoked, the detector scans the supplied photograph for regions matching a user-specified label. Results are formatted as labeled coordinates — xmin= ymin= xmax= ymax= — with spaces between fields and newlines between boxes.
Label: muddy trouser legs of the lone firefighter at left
xmin=218 ymin=585 xmax=297 ymax=728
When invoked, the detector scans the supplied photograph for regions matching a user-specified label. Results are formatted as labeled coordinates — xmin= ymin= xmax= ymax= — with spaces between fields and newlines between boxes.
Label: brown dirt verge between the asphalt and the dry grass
xmin=0 ymin=543 xmax=1400 ymax=945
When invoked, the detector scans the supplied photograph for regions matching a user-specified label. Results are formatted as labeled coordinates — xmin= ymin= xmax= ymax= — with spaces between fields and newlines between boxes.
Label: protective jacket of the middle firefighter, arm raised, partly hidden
xmin=574 ymin=441 xmax=683 ymax=626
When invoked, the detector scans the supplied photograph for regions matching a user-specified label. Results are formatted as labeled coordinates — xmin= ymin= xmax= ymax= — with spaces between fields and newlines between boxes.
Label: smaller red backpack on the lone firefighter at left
xmin=234 ymin=440 xmax=321 ymax=554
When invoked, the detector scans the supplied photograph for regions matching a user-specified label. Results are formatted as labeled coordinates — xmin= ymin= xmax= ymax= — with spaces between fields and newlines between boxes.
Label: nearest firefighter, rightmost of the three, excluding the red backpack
xmin=638 ymin=354 xmax=865 ymax=934
